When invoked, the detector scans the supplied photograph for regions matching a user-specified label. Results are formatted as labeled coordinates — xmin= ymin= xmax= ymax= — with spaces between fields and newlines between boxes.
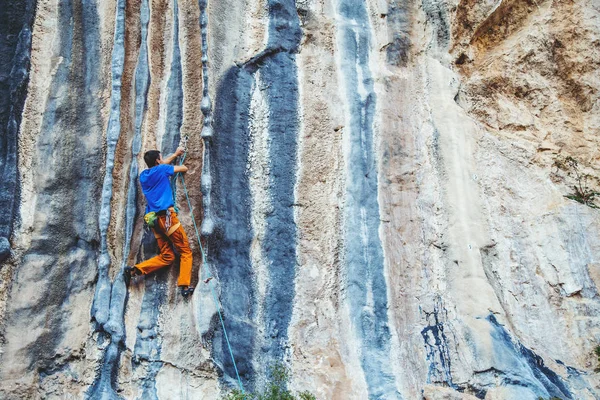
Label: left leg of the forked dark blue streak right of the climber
xmin=205 ymin=67 xmax=256 ymax=387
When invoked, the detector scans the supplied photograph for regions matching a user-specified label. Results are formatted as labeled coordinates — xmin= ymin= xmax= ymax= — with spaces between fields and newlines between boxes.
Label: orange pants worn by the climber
xmin=135 ymin=209 xmax=192 ymax=286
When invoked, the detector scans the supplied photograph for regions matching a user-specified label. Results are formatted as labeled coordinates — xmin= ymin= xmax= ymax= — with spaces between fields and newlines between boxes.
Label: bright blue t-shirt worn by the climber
xmin=140 ymin=164 xmax=175 ymax=213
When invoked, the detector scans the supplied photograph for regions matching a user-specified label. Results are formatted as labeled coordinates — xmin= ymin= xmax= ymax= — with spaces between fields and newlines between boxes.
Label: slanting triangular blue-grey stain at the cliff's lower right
xmin=482 ymin=314 xmax=573 ymax=399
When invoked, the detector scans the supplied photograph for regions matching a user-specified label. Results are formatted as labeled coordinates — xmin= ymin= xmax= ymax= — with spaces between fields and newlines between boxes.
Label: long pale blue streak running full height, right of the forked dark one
xmin=337 ymin=0 xmax=400 ymax=399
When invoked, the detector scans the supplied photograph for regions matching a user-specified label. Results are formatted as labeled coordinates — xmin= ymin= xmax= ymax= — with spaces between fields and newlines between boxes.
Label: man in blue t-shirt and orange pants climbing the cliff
xmin=125 ymin=147 xmax=194 ymax=297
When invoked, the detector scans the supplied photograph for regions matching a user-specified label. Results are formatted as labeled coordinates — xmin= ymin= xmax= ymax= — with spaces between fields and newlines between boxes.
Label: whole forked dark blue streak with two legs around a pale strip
xmin=209 ymin=0 xmax=302 ymax=384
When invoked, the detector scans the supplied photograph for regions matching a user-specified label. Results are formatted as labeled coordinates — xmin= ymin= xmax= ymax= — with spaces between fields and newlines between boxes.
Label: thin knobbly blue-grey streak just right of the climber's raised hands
xmin=198 ymin=0 xmax=215 ymax=234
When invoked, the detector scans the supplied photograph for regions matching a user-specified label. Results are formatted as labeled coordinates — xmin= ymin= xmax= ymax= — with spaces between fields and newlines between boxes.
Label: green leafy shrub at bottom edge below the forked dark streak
xmin=223 ymin=363 xmax=317 ymax=400
